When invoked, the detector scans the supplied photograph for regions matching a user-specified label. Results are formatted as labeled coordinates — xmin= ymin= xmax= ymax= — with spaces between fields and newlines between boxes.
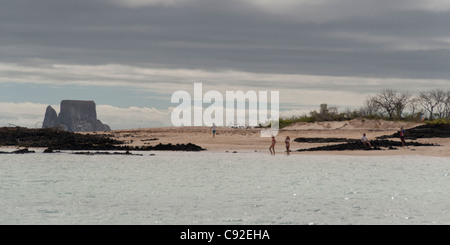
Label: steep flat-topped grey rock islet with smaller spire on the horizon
xmin=42 ymin=100 xmax=111 ymax=132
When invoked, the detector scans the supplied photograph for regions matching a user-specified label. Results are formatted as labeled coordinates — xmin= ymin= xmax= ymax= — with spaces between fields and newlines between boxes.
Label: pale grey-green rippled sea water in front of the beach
xmin=0 ymin=152 xmax=450 ymax=225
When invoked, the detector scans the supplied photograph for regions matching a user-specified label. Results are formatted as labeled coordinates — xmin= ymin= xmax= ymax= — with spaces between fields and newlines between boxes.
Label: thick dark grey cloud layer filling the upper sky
xmin=0 ymin=0 xmax=450 ymax=79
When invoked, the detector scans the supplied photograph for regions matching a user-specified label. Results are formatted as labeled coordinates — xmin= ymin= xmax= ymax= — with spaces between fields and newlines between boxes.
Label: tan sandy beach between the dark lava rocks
xmin=97 ymin=119 xmax=450 ymax=157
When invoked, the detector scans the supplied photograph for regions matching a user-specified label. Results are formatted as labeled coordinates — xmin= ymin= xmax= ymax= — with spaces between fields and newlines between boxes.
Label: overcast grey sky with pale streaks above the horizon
xmin=0 ymin=0 xmax=450 ymax=129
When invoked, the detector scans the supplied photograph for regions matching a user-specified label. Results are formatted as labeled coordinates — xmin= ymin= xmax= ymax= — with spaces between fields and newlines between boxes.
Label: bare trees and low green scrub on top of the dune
xmin=279 ymin=89 xmax=450 ymax=128
